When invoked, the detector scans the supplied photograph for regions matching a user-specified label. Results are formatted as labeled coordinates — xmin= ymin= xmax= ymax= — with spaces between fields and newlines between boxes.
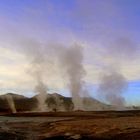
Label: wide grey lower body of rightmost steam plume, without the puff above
xmin=99 ymin=71 xmax=127 ymax=109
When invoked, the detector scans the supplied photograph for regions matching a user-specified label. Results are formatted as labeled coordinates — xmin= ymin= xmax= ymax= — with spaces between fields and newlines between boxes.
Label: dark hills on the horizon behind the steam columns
xmin=0 ymin=93 xmax=112 ymax=111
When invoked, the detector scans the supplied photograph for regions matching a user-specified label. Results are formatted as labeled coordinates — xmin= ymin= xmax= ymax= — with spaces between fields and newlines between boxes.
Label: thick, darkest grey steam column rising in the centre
xmin=57 ymin=45 xmax=86 ymax=110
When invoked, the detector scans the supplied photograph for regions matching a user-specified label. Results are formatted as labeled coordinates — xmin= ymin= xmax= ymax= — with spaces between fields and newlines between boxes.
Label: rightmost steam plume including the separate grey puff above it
xmin=99 ymin=38 xmax=137 ymax=109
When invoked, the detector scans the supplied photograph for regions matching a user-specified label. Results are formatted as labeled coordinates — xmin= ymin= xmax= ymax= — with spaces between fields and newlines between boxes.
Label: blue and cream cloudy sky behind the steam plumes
xmin=0 ymin=0 xmax=140 ymax=105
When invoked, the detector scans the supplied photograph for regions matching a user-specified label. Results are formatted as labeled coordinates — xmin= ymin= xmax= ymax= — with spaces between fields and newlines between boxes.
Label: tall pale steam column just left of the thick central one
xmin=21 ymin=40 xmax=47 ymax=111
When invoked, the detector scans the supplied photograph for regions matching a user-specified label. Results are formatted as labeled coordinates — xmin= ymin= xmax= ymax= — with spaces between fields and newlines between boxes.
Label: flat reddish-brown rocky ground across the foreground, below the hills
xmin=0 ymin=111 xmax=140 ymax=140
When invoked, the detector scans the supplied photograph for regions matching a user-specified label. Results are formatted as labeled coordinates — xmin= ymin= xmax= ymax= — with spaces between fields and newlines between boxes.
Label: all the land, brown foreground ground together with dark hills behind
xmin=0 ymin=93 xmax=140 ymax=140
